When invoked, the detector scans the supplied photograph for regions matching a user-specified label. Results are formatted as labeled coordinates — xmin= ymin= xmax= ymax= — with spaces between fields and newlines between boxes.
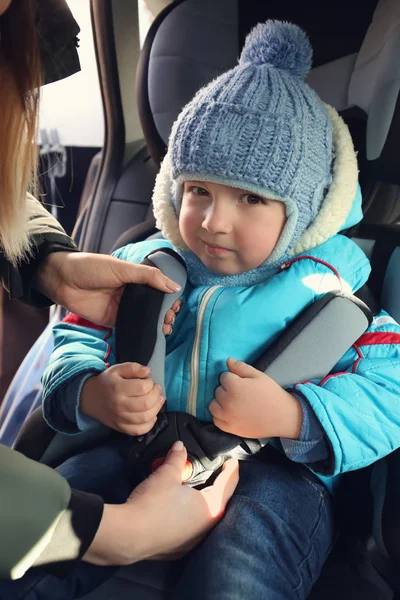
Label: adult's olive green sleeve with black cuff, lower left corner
xmin=0 ymin=445 xmax=103 ymax=579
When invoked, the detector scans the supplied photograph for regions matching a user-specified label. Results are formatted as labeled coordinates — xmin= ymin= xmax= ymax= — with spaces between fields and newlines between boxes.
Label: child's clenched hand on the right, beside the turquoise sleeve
xmin=209 ymin=358 xmax=302 ymax=439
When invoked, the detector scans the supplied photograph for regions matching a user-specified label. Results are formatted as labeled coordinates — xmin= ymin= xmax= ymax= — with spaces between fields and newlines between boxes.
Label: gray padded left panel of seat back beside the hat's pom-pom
xmin=148 ymin=0 xmax=239 ymax=142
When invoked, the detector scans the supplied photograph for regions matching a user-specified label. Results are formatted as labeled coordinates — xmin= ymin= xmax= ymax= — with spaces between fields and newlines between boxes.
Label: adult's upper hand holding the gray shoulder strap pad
xmin=35 ymin=252 xmax=180 ymax=327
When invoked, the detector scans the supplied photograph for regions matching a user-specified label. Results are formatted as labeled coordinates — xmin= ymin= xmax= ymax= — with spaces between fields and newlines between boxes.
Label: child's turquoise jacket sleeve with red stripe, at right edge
xmin=294 ymin=311 xmax=400 ymax=476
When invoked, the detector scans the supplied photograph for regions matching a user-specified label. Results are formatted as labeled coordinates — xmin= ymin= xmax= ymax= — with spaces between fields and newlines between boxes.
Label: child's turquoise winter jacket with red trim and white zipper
xmin=43 ymin=235 xmax=400 ymax=487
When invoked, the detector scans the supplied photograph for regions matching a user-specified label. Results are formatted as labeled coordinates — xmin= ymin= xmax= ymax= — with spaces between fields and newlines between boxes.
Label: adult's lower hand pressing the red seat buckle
xmin=84 ymin=442 xmax=239 ymax=565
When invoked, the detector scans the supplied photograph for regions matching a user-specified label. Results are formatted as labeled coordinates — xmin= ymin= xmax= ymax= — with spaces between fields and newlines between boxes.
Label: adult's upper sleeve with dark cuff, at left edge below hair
xmin=0 ymin=194 xmax=77 ymax=307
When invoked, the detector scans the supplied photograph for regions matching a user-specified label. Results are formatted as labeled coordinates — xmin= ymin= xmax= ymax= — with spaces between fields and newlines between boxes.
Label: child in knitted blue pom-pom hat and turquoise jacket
xmin=8 ymin=21 xmax=400 ymax=600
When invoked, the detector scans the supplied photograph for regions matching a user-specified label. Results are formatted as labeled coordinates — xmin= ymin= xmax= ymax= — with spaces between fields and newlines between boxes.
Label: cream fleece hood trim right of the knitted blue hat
xmin=291 ymin=104 xmax=358 ymax=255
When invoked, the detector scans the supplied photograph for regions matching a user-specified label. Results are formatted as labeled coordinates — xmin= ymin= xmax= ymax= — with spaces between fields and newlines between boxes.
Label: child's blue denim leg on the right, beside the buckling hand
xmin=175 ymin=461 xmax=334 ymax=600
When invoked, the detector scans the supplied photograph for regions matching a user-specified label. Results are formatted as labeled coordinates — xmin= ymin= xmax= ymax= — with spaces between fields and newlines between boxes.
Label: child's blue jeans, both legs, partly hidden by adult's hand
xmin=0 ymin=445 xmax=334 ymax=600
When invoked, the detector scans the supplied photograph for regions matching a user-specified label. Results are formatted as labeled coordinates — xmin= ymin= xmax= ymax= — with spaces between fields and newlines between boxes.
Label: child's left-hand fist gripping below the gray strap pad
xmin=79 ymin=363 xmax=165 ymax=435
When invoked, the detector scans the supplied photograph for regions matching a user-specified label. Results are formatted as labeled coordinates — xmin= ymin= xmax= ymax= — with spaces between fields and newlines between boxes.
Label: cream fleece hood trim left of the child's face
xmin=152 ymin=152 xmax=188 ymax=250
